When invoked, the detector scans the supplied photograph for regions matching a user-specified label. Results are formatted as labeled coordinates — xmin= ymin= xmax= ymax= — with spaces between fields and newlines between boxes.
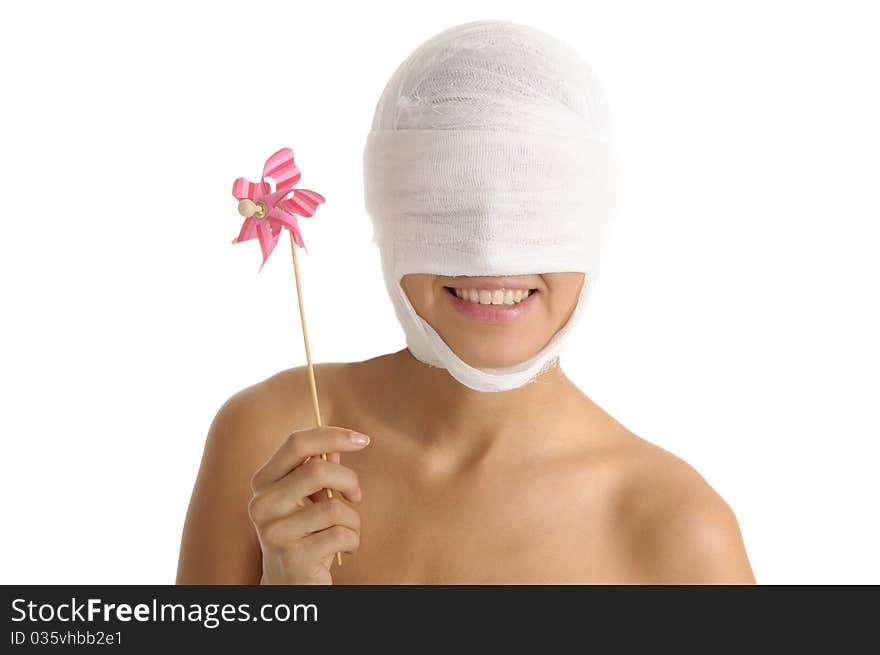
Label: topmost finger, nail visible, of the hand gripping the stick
xmin=251 ymin=426 xmax=369 ymax=491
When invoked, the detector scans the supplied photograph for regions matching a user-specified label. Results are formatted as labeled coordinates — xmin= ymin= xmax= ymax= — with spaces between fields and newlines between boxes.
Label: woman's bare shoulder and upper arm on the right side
xmin=616 ymin=435 xmax=755 ymax=584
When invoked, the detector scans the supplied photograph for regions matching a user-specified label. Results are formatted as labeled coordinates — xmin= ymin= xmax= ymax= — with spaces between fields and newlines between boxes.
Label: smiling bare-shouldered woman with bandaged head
xmin=177 ymin=21 xmax=754 ymax=584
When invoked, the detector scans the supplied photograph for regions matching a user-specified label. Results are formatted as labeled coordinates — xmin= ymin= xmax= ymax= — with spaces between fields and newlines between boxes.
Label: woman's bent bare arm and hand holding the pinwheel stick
xmin=177 ymin=364 xmax=364 ymax=584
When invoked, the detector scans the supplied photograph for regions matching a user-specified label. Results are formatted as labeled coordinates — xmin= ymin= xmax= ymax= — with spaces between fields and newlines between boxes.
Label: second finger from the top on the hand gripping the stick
xmin=248 ymin=457 xmax=361 ymax=525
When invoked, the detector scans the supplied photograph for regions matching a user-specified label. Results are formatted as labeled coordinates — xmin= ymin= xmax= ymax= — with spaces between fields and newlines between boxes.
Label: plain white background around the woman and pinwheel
xmin=0 ymin=0 xmax=880 ymax=583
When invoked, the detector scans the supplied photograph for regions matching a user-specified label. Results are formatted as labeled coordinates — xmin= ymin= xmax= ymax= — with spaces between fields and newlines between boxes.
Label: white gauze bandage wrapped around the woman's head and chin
xmin=364 ymin=21 xmax=616 ymax=391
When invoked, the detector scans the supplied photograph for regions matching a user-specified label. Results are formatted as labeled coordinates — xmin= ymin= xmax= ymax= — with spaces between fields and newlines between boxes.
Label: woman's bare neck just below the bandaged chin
xmin=382 ymin=348 xmax=583 ymax=459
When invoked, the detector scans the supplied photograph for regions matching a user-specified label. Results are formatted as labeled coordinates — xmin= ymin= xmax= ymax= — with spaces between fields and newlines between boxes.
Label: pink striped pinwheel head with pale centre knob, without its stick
xmin=232 ymin=148 xmax=324 ymax=271
